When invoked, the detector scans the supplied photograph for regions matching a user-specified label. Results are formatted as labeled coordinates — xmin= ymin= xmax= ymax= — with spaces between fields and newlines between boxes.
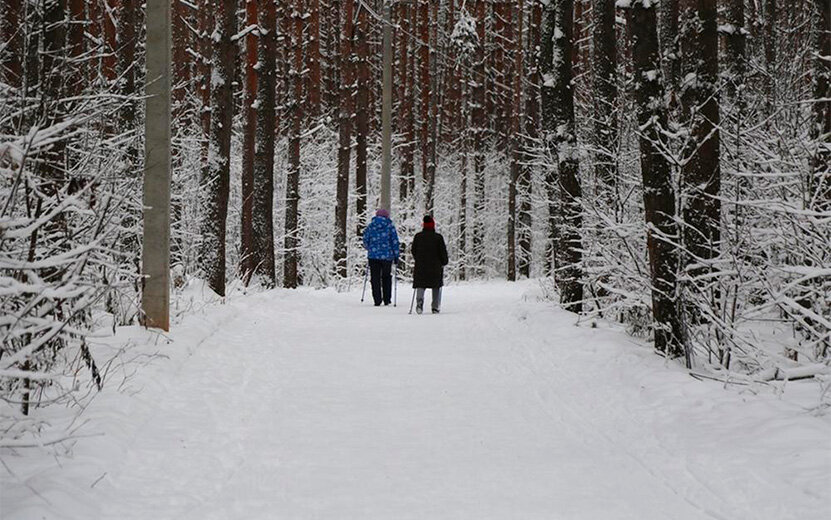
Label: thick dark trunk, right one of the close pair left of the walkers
xmin=254 ymin=0 xmax=277 ymax=288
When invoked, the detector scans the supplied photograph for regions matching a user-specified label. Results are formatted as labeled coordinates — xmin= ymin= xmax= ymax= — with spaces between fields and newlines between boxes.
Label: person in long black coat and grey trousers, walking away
xmin=412 ymin=215 xmax=447 ymax=314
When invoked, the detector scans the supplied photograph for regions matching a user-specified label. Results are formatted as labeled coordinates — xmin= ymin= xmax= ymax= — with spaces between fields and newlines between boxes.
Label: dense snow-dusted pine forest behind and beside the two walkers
xmin=0 ymin=0 xmax=831 ymax=416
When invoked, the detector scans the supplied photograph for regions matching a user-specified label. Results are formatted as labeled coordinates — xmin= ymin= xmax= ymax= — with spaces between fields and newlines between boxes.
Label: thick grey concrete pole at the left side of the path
xmin=141 ymin=0 xmax=171 ymax=330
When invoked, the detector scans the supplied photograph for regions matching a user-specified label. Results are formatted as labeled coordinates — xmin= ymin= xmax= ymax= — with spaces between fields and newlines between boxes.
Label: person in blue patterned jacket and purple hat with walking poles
xmin=364 ymin=208 xmax=400 ymax=307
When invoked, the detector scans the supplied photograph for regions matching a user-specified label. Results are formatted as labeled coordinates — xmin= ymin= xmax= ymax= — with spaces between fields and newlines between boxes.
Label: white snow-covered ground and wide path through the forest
xmin=0 ymin=281 xmax=831 ymax=520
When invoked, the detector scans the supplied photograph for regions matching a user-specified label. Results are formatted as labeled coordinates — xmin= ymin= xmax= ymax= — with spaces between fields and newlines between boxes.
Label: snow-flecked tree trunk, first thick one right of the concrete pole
xmin=199 ymin=0 xmax=232 ymax=296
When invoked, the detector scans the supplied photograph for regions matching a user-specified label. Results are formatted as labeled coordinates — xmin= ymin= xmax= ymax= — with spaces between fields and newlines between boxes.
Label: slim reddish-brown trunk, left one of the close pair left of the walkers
xmin=240 ymin=0 xmax=256 ymax=285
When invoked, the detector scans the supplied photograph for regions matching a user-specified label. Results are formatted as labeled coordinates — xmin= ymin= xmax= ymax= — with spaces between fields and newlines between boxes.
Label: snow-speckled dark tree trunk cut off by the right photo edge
xmin=811 ymin=0 xmax=831 ymax=211
